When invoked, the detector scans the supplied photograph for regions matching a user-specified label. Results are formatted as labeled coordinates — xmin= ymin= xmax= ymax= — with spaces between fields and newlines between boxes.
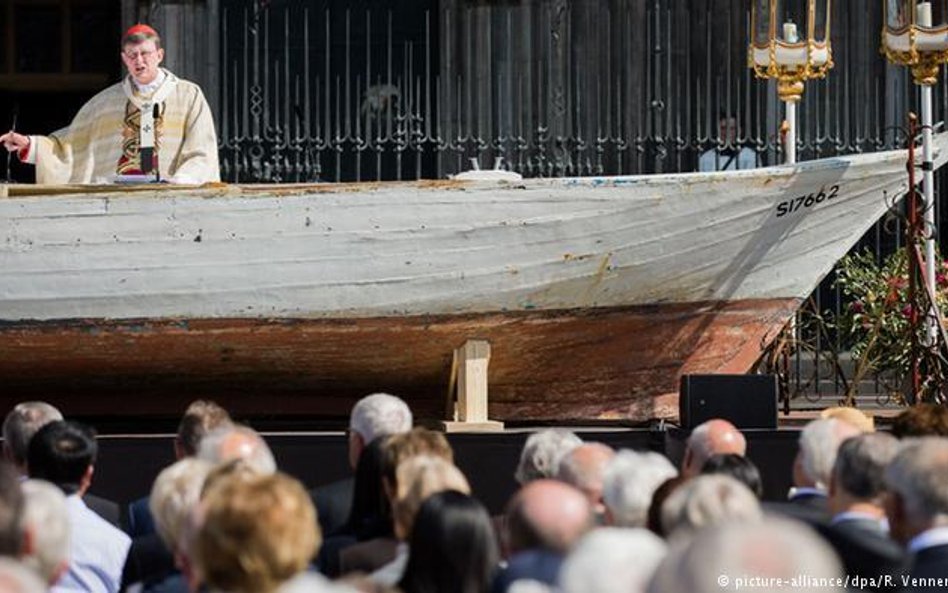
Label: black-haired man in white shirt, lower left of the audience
xmin=27 ymin=420 xmax=131 ymax=593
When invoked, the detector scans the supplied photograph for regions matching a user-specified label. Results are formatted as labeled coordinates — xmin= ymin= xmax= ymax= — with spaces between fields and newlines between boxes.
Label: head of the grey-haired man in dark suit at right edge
xmin=885 ymin=437 xmax=948 ymax=543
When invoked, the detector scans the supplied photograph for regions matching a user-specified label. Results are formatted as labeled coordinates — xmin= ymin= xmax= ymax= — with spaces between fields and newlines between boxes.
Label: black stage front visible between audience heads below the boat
xmin=92 ymin=427 xmax=799 ymax=513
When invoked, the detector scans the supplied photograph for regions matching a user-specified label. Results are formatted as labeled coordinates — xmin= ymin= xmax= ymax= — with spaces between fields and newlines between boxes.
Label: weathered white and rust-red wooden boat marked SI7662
xmin=0 ymin=134 xmax=946 ymax=421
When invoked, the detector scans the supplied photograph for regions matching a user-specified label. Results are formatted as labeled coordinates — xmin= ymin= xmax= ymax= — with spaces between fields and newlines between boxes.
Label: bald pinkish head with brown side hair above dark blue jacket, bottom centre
xmin=507 ymin=479 xmax=594 ymax=554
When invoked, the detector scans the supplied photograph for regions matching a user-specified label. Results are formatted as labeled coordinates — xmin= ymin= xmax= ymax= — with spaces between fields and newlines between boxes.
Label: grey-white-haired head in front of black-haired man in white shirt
xmin=19 ymin=480 xmax=71 ymax=590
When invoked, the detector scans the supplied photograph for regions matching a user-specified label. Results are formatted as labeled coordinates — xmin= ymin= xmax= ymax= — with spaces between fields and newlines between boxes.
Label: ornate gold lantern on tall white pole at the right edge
xmin=882 ymin=0 xmax=948 ymax=344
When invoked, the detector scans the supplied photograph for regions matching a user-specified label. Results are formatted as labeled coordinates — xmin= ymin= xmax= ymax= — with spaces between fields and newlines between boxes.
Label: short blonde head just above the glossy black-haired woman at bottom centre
xmin=392 ymin=455 xmax=471 ymax=540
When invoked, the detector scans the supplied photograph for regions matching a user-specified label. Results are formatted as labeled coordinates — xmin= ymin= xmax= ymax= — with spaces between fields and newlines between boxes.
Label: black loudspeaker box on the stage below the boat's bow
xmin=678 ymin=375 xmax=777 ymax=430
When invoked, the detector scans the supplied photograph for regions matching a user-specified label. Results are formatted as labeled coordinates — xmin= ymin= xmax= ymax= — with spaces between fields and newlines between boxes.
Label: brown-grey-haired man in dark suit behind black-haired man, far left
xmin=3 ymin=401 xmax=122 ymax=527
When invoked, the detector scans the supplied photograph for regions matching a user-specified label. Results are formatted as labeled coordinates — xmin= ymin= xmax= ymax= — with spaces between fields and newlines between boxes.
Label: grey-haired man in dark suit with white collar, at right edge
xmin=885 ymin=437 xmax=948 ymax=593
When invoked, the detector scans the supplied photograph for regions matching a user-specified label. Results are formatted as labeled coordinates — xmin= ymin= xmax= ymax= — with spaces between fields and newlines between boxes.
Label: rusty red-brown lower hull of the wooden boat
xmin=0 ymin=299 xmax=797 ymax=421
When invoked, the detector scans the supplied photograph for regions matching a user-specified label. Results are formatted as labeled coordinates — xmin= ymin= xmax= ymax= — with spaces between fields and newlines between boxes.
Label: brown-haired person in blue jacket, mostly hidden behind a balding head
xmin=126 ymin=399 xmax=233 ymax=539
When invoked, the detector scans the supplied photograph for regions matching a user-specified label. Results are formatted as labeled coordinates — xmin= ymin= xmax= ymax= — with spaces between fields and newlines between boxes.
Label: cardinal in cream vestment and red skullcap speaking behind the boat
xmin=0 ymin=24 xmax=220 ymax=184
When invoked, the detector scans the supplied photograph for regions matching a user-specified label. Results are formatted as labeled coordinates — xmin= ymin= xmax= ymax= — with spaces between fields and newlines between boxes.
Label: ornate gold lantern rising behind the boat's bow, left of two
xmin=747 ymin=0 xmax=833 ymax=163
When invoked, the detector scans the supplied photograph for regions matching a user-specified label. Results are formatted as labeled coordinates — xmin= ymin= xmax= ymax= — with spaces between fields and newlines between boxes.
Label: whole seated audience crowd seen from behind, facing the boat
xmin=0 ymin=393 xmax=948 ymax=593
